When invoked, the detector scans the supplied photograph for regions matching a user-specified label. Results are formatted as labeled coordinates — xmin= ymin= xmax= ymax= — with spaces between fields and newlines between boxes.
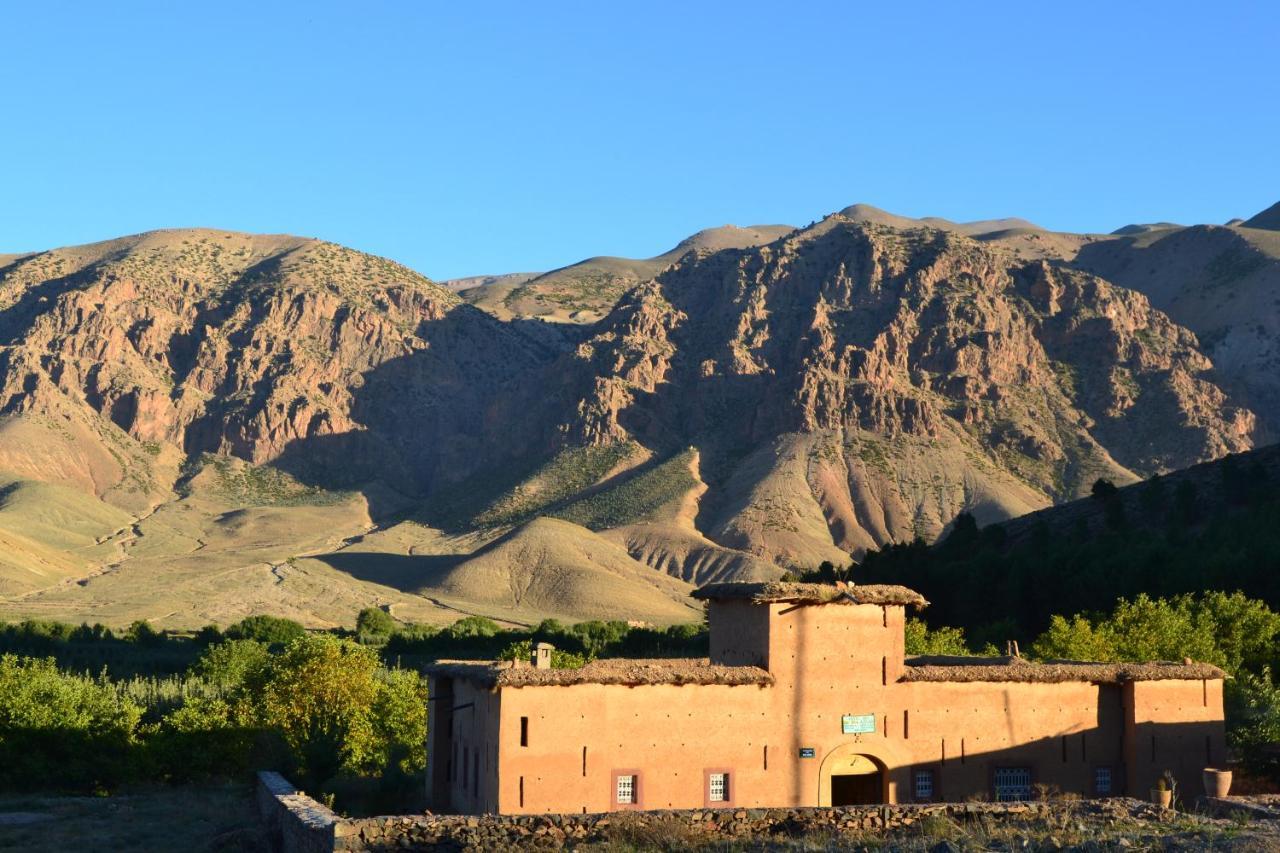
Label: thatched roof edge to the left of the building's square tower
xmin=426 ymin=657 xmax=773 ymax=688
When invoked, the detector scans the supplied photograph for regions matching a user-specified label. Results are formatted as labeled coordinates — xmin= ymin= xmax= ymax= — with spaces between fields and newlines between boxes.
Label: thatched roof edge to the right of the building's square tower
xmin=902 ymin=656 xmax=1226 ymax=684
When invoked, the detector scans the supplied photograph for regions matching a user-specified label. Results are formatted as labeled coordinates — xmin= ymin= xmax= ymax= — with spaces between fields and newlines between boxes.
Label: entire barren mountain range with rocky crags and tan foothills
xmin=0 ymin=199 xmax=1280 ymax=626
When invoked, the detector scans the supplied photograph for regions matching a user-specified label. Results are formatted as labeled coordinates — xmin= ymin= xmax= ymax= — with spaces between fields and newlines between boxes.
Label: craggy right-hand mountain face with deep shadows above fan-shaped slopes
xmin=524 ymin=216 xmax=1254 ymax=564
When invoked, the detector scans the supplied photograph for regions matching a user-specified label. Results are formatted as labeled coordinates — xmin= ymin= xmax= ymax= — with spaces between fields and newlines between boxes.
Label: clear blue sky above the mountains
xmin=0 ymin=0 xmax=1280 ymax=278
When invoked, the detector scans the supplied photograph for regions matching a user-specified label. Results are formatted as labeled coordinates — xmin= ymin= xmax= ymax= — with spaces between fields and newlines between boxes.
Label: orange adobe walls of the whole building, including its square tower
xmin=435 ymin=602 xmax=1222 ymax=815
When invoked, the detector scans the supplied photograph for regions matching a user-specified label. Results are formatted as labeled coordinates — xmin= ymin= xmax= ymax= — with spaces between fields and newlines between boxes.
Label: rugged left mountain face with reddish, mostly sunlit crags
xmin=0 ymin=231 xmax=565 ymax=502
